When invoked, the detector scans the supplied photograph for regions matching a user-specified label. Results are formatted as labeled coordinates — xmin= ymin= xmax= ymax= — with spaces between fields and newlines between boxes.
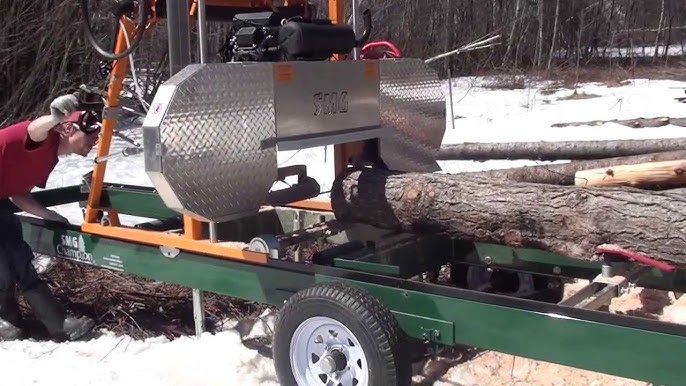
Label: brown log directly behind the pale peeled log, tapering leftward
xmin=464 ymin=150 xmax=686 ymax=185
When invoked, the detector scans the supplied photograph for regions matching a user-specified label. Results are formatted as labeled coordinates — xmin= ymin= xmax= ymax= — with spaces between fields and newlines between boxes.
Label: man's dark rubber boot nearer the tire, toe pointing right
xmin=24 ymin=283 xmax=95 ymax=341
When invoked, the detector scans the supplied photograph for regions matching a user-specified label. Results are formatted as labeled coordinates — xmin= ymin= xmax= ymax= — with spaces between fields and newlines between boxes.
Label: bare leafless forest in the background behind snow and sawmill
xmin=0 ymin=0 xmax=686 ymax=126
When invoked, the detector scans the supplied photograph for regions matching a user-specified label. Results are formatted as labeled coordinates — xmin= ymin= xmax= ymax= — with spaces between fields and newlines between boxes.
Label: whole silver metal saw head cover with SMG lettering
xmin=143 ymin=59 xmax=445 ymax=222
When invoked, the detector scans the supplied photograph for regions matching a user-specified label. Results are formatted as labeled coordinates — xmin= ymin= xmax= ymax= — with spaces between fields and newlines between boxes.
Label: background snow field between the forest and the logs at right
xmin=439 ymin=77 xmax=686 ymax=173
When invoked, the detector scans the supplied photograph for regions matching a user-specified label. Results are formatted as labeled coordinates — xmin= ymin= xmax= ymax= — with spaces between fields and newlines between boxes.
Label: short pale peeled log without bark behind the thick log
xmin=575 ymin=159 xmax=686 ymax=188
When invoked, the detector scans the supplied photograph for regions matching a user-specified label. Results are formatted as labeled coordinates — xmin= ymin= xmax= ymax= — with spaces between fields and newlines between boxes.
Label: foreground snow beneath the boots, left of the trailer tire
xmin=0 ymin=310 xmax=278 ymax=386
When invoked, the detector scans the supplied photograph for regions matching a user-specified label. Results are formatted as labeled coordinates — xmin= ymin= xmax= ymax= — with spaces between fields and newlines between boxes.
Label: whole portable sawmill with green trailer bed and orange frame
xmin=8 ymin=0 xmax=686 ymax=386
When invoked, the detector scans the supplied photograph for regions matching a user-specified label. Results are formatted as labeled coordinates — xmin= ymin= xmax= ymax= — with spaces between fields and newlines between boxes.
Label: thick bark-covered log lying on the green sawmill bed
xmin=331 ymin=169 xmax=686 ymax=266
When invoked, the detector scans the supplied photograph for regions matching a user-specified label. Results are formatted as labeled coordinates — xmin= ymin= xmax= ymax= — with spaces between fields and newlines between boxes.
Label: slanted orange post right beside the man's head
xmin=85 ymin=19 xmax=133 ymax=223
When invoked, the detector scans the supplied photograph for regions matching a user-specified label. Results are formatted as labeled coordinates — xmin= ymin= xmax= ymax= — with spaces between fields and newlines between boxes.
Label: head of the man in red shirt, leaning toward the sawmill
xmin=59 ymin=111 xmax=101 ymax=157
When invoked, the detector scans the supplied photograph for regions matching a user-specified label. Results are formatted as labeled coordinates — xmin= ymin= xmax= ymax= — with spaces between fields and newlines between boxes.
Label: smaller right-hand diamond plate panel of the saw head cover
xmin=379 ymin=58 xmax=446 ymax=172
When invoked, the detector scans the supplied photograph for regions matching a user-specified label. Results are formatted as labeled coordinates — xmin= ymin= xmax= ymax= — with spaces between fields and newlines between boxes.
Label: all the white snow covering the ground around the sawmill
xmin=0 ymin=71 xmax=686 ymax=386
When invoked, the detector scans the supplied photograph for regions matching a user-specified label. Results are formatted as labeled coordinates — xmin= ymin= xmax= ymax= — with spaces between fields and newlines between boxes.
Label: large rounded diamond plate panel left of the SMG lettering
xmin=144 ymin=63 xmax=277 ymax=222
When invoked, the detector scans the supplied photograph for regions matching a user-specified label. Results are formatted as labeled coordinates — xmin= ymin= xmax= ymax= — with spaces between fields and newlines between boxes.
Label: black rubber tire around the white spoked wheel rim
xmin=273 ymin=282 xmax=412 ymax=386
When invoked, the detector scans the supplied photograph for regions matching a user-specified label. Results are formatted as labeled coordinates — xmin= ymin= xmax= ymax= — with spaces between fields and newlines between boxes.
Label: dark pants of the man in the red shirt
xmin=0 ymin=205 xmax=41 ymax=292
